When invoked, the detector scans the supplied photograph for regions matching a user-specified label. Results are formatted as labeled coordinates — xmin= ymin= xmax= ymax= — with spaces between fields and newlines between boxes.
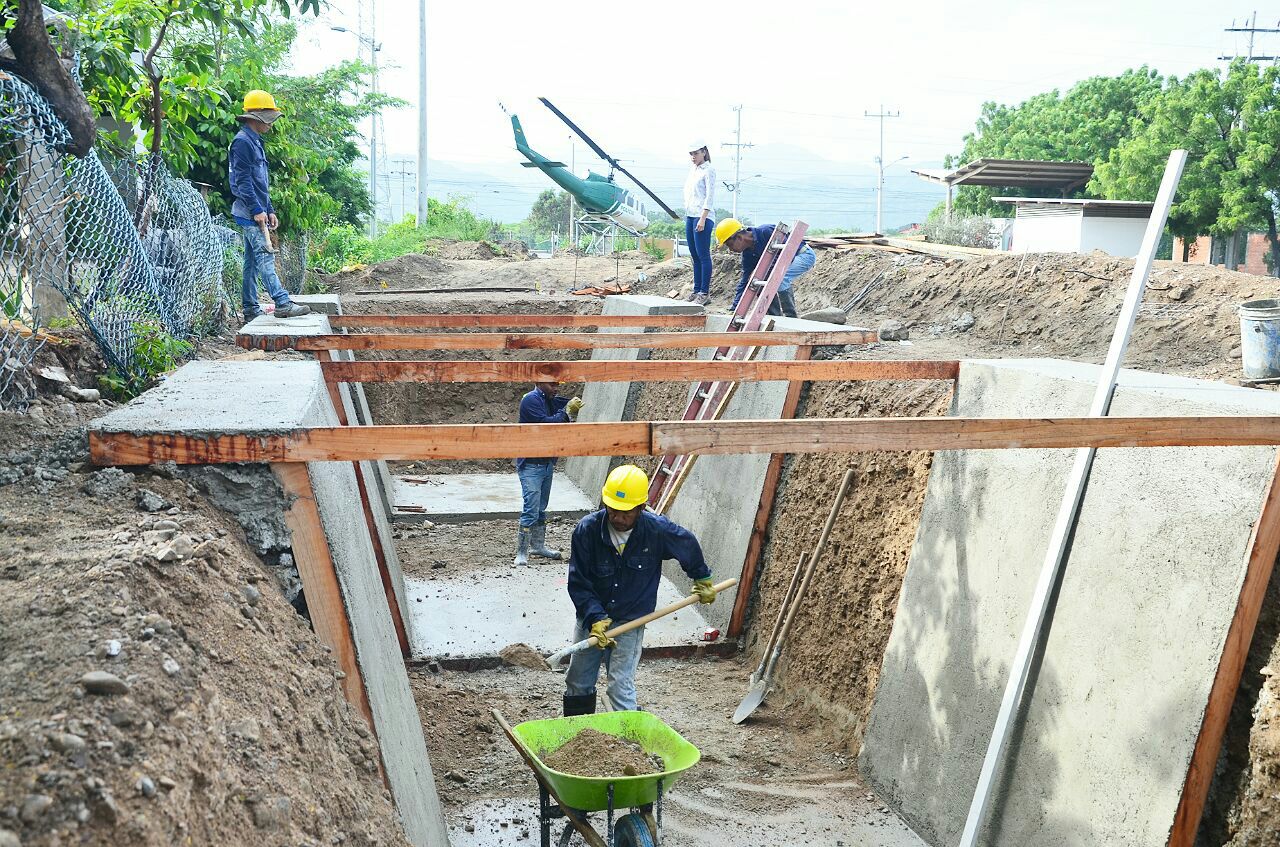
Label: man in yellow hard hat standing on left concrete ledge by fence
xmin=227 ymin=88 xmax=311 ymax=324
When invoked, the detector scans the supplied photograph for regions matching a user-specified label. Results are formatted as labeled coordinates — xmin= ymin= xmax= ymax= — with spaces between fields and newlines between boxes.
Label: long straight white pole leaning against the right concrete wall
xmin=960 ymin=150 xmax=1187 ymax=847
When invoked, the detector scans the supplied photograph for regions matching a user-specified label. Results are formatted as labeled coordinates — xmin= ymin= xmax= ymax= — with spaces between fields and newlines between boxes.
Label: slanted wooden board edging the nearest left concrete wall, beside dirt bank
xmin=271 ymin=464 xmax=376 ymax=732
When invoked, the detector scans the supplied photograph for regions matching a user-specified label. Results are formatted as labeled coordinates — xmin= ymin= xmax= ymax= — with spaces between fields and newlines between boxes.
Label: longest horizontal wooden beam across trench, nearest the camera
xmin=88 ymin=419 xmax=1280 ymax=464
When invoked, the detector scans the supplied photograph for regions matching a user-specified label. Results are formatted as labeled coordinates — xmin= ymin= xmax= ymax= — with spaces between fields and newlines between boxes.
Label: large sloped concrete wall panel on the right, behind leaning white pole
xmin=859 ymin=360 xmax=1280 ymax=847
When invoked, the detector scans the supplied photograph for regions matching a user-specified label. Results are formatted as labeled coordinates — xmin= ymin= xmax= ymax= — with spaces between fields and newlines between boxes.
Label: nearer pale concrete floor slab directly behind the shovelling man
xmin=406 ymin=568 xmax=707 ymax=659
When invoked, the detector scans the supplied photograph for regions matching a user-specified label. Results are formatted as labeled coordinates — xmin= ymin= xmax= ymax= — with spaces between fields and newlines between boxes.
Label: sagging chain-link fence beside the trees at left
xmin=0 ymin=73 xmax=307 ymax=408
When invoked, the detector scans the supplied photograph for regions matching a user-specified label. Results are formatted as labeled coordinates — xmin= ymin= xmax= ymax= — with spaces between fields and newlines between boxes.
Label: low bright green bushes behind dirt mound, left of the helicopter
xmin=310 ymin=197 xmax=502 ymax=274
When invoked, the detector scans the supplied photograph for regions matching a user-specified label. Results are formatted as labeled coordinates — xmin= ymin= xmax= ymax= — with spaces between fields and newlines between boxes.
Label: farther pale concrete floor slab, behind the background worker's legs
xmin=392 ymin=471 xmax=595 ymax=523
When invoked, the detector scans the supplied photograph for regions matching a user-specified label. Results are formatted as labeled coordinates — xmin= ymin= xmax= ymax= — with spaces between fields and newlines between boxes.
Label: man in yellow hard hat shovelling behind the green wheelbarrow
xmin=564 ymin=464 xmax=716 ymax=716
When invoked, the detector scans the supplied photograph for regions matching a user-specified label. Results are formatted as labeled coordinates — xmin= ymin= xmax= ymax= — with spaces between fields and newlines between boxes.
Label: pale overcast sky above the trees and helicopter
xmin=293 ymin=0 xmax=1280 ymax=227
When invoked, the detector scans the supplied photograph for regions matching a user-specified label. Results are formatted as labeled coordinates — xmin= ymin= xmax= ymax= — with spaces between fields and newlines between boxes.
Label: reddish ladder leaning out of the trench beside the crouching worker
xmin=649 ymin=220 xmax=809 ymax=514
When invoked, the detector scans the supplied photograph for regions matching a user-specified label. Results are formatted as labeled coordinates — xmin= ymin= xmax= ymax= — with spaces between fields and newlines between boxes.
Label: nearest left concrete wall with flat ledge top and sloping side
xmin=91 ymin=360 xmax=448 ymax=847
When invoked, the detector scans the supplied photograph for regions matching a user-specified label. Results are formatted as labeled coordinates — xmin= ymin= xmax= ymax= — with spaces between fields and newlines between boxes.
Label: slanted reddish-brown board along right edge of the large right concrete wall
xmin=1169 ymin=455 xmax=1280 ymax=847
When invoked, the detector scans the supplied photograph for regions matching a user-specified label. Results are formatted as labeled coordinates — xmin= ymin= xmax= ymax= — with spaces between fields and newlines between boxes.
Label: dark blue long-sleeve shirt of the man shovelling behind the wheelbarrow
xmin=568 ymin=509 xmax=712 ymax=627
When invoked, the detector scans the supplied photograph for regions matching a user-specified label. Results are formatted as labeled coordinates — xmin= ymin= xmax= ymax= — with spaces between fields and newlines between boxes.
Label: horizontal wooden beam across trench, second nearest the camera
xmin=320 ymin=360 xmax=960 ymax=383
